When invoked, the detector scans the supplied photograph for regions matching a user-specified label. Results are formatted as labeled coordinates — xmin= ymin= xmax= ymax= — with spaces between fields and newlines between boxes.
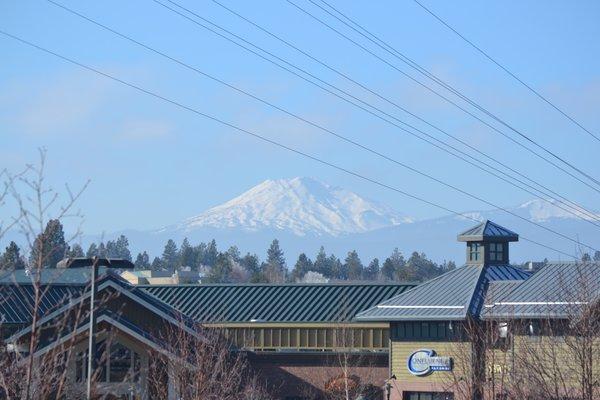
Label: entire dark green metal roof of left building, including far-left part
xmin=0 ymin=271 xmax=416 ymax=324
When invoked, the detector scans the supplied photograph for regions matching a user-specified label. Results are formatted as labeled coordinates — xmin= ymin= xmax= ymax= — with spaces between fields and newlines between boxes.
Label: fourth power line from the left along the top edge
xmin=205 ymin=0 xmax=598 ymax=225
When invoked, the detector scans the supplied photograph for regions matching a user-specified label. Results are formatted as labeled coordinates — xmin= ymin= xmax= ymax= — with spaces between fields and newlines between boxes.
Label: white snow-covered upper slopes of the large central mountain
xmin=161 ymin=178 xmax=412 ymax=236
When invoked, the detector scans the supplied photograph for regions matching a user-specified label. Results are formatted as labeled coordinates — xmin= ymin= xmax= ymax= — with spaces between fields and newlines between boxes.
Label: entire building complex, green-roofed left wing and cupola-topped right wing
xmin=0 ymin=221 xmax=600 ymax=400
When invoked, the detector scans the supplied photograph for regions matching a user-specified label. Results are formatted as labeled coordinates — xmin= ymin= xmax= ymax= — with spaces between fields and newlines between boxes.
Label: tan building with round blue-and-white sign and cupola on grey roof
xmin=356 ymin=221 xmax=600 ymax=400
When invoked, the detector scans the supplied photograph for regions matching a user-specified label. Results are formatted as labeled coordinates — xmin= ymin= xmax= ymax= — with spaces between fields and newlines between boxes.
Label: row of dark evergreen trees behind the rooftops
xmin=0 ymin=220 xmax=464 ymax=283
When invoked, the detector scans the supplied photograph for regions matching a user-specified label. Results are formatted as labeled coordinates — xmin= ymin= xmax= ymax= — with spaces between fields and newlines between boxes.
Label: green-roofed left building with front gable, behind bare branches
xmin=0 ymin=268 xmax=414 ymax=399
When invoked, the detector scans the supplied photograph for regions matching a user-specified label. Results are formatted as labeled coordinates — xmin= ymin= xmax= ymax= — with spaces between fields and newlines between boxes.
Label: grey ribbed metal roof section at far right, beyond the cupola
xmin=483 ymin=263 xmax=600 ymax=319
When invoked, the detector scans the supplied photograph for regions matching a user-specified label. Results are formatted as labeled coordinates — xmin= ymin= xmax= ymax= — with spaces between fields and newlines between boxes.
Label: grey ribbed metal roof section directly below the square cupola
xmin=356 ymin=265 xmax=529 ymax=321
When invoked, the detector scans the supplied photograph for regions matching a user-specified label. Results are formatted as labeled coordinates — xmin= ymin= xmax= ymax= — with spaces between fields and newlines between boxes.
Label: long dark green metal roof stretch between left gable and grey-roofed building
xmin=138 ymin=283 xmax=416 ymax=323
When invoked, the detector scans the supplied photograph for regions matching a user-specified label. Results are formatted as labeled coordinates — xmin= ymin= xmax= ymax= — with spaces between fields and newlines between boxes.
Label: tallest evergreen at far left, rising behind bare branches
xmin=29 ymin=219 xmax=67 ymax=268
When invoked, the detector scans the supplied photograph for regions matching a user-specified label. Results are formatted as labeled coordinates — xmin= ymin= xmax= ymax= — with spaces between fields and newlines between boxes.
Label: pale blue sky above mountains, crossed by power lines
xmin=0 ymin=0 xmax=600 ymax=233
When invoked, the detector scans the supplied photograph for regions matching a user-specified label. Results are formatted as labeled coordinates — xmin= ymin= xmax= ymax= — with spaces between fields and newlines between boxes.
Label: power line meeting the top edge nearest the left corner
xmin=38 ymin=0 xmax=600 ymax=234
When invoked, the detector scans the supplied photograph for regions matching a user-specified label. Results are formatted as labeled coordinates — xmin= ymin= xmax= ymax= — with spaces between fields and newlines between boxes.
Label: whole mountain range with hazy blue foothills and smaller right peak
xmin=63 ymin=178 xmax=600 ymax=263
